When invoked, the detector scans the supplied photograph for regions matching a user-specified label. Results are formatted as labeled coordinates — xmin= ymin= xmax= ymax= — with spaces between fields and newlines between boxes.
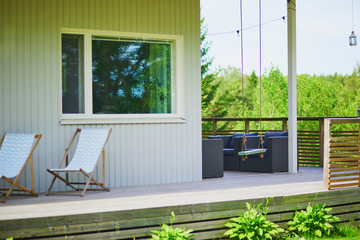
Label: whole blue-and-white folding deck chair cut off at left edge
xmin=0 ymin=133 xmax=41 ymax=202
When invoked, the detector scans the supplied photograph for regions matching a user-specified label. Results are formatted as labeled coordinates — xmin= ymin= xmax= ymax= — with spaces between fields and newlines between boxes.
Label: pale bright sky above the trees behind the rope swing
xmin=201 ymin=0 xmax=360 ymax=75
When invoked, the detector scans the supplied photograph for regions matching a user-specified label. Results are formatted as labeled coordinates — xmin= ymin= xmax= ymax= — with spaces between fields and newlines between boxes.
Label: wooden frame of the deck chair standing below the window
xmin=46 ymin=128 xmax=112 ymax=197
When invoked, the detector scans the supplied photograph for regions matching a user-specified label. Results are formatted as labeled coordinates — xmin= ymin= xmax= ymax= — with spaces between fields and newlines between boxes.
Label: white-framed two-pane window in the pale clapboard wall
xmin=61 ymin=31 xmax=183 ymax=123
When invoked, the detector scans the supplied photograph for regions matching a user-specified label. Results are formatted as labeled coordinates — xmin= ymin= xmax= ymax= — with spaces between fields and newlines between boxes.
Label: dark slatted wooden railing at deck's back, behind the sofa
xmin=202 ymin=117 xmax=354 ymax=167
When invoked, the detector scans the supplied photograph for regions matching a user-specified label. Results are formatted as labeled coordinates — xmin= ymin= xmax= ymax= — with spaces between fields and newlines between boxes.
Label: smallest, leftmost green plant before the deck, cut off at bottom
xmin=151 ymin=212 xmax=195 ymax=240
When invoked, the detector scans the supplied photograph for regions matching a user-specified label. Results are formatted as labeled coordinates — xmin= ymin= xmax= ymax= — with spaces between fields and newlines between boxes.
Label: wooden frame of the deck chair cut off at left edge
xmin=0 ymin=133 xmax=42 ymax=203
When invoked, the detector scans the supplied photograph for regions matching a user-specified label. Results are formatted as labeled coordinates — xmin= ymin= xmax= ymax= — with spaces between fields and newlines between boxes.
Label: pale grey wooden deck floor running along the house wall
xmin=0 ymin=167 xmax=326 ymax=221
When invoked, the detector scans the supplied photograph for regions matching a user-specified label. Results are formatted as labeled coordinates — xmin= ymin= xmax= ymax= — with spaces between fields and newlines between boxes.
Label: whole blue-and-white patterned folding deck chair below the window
xmin=47 ymin=128 xmax=112 ymax=196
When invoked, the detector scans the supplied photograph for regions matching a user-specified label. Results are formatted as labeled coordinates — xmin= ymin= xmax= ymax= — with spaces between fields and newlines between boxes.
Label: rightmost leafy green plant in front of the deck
xmin=288 ymin=196 xmax=340 ymax=239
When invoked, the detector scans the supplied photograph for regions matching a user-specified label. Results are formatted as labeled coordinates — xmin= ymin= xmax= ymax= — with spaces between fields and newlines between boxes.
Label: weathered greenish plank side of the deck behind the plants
xmin=0 ymin=188 xmax=360 ymax=239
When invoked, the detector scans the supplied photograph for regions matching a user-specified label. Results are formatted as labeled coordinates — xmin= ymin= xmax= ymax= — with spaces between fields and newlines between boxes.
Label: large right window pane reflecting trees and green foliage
xmin=92 ymin=37 xmax=172 ymax=114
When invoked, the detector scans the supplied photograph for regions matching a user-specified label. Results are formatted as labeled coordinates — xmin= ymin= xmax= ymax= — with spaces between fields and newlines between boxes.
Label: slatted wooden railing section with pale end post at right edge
xmin=323 ymin=118 xmax=360 ymax=189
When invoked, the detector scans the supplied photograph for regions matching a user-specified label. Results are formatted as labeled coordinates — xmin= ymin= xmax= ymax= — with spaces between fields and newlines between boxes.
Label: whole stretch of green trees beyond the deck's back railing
xmin=203 ymin=66 xmax=360 ymax=130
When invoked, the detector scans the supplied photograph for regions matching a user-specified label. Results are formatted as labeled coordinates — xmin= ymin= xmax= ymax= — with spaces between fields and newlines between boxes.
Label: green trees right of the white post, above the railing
xmin=297 ymin=67 xmax=360 ymax=130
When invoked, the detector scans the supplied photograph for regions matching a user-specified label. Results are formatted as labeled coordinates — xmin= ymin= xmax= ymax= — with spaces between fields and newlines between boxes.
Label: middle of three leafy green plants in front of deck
xmin=224 ymin=198 xmax=284 ymax=240
